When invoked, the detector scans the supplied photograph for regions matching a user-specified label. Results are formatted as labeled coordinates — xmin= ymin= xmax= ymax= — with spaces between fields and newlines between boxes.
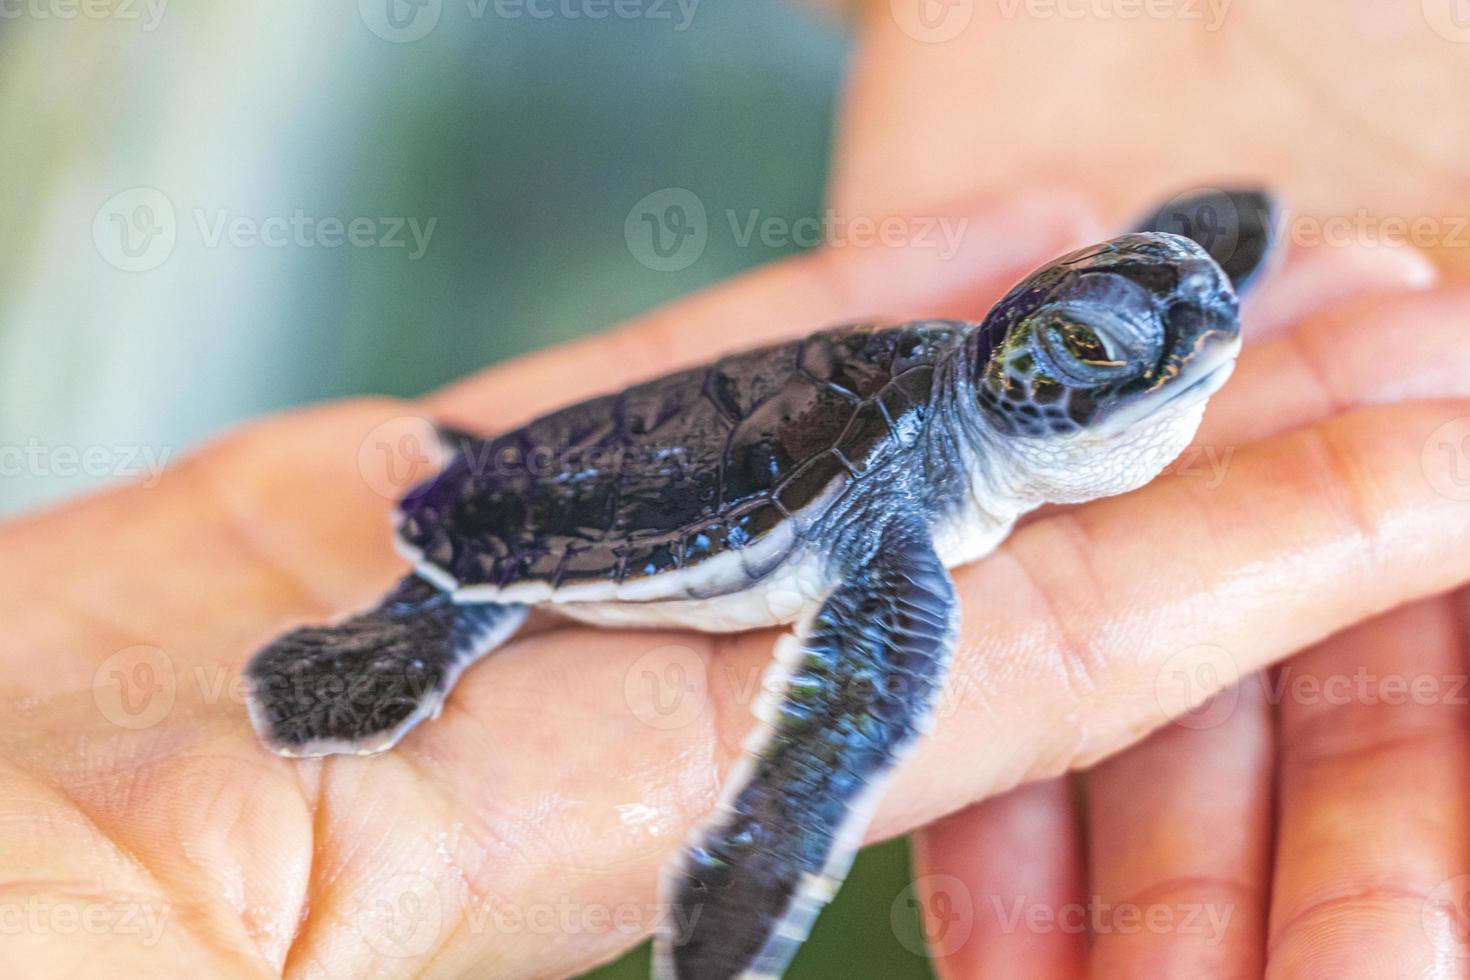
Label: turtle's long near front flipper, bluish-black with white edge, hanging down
xmin=656 ymin=527 xmax=956 ymax=980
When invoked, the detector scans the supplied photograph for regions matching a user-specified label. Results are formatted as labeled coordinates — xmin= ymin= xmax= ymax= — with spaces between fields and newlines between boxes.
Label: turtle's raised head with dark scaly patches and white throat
xmin=969 ymin=234 xmax=1241 ymax=502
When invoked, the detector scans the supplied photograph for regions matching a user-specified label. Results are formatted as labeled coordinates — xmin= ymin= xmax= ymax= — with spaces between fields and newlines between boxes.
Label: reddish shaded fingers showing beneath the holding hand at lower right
xmin=916 ymin=592 xmax=1470 ymax=980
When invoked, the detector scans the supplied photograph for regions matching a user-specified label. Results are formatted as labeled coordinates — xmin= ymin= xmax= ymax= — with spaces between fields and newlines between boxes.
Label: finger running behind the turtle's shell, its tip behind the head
xmin=426 ymin=190 xmax=1101 ymax=429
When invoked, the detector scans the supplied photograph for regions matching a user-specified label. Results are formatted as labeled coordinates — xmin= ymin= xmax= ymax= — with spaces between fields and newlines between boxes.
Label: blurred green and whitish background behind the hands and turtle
xmin=0 ymin=0 xmax=931 ymax=980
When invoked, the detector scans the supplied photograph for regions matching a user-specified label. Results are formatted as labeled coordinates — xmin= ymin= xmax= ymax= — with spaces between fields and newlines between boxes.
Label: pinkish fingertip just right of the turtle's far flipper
xmin=1242 ymin=244 xmax=1439 ymax=341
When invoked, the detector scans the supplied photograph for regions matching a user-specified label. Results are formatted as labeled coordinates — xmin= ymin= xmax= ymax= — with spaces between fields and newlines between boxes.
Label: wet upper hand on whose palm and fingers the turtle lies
xmin=11 ymin=183 xmax=1470 ymax=977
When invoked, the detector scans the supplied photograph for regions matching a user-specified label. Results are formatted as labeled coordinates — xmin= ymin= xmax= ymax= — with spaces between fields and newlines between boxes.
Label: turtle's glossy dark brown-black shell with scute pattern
xmin=400 ymin=322 xmax=969 ymax=589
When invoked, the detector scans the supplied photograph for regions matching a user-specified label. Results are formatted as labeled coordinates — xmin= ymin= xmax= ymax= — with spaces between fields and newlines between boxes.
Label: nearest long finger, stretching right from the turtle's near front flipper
xmin=895 ymin=400 xmax=1470 ymax=813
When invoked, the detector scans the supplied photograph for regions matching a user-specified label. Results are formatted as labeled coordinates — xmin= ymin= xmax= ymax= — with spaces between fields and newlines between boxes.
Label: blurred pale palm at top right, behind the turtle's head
xmin=831 ymin=0 xmax=1470 ymax=275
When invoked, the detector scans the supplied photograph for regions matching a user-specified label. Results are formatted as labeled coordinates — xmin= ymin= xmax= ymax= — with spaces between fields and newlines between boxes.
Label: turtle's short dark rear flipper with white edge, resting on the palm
xmin=245 ymin=574 xmax=526 ymax=755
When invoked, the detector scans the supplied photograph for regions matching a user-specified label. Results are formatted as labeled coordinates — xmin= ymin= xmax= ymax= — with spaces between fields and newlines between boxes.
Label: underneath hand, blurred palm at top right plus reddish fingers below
xmin=833 ymin=7 xmax=1470 ymax=977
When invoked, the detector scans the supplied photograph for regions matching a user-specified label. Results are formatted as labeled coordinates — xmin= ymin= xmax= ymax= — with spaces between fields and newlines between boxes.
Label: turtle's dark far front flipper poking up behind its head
xmin=1133 ymin=187 xmax=1280 ymax=294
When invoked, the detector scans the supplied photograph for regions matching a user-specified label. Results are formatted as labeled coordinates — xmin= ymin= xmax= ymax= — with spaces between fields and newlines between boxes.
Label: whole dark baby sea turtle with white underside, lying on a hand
xmin=248 ymin=191 xmax=1272 ymax=980
